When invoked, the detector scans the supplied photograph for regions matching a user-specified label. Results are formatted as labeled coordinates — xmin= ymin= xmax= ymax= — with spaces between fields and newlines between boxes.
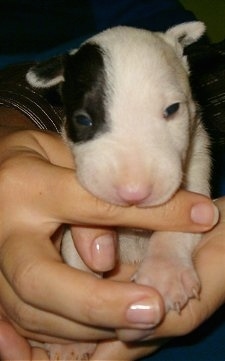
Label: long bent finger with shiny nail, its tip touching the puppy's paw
xmin=0 ymin=233 xmax=164 ymax=329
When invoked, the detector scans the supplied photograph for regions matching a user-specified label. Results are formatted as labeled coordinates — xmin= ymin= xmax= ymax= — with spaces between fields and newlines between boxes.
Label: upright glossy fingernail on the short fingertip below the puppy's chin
xmin=92 ymin=234 xmax=116 ymax=272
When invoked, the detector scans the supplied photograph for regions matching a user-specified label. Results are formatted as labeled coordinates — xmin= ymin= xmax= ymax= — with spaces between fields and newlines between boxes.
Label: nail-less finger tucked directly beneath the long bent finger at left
xmin=0 ymin=277 xmax=115 ymax=343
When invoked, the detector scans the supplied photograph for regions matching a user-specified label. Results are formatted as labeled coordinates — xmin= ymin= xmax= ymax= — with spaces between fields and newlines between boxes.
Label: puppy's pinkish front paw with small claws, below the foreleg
xmin=133 ymin=257 xmax=200 ymax=313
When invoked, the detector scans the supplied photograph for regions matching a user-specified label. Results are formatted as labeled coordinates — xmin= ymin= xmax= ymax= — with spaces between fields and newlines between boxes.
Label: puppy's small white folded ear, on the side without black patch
xmin=166 ymin=21 xmax=205 ymax=48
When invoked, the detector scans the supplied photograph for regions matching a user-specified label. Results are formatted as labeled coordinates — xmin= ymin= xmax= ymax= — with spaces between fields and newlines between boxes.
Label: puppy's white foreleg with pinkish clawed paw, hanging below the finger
xmin=134 ymin=232 xmax=200 ymax=312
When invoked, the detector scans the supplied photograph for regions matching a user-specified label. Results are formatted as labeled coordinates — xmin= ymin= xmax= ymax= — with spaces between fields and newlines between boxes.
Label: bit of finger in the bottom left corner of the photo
xmin=0 ymin=320 xmax=49 ymax=361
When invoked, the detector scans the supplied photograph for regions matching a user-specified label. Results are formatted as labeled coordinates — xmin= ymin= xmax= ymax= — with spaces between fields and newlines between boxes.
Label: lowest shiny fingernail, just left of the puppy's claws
xmin=126 ymin=299 xmax=161 ymax=328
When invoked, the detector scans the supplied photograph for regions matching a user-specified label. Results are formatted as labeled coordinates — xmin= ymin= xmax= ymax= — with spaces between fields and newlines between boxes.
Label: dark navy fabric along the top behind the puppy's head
xmin=0 ymin=0 xmax=194 ymax=67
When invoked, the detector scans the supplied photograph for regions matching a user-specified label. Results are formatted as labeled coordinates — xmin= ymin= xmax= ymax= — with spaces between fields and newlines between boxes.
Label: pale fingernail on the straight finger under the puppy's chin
xmin=191 ymin=203 xmax=219 ymax=226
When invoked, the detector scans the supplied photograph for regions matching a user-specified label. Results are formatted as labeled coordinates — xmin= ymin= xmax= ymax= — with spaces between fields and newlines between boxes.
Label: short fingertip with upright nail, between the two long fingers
xmin=71 ymin=226 xmax=117 ymax=272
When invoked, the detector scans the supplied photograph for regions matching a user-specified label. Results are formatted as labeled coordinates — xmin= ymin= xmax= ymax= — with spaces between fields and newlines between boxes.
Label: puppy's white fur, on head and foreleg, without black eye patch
xmin=62 ymin=22 xmax=210 ymax=286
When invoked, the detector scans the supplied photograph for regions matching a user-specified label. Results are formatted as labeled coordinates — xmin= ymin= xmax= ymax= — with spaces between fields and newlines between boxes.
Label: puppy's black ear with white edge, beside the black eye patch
xmin=26 ymin=56 xmax=64 ymax=88
